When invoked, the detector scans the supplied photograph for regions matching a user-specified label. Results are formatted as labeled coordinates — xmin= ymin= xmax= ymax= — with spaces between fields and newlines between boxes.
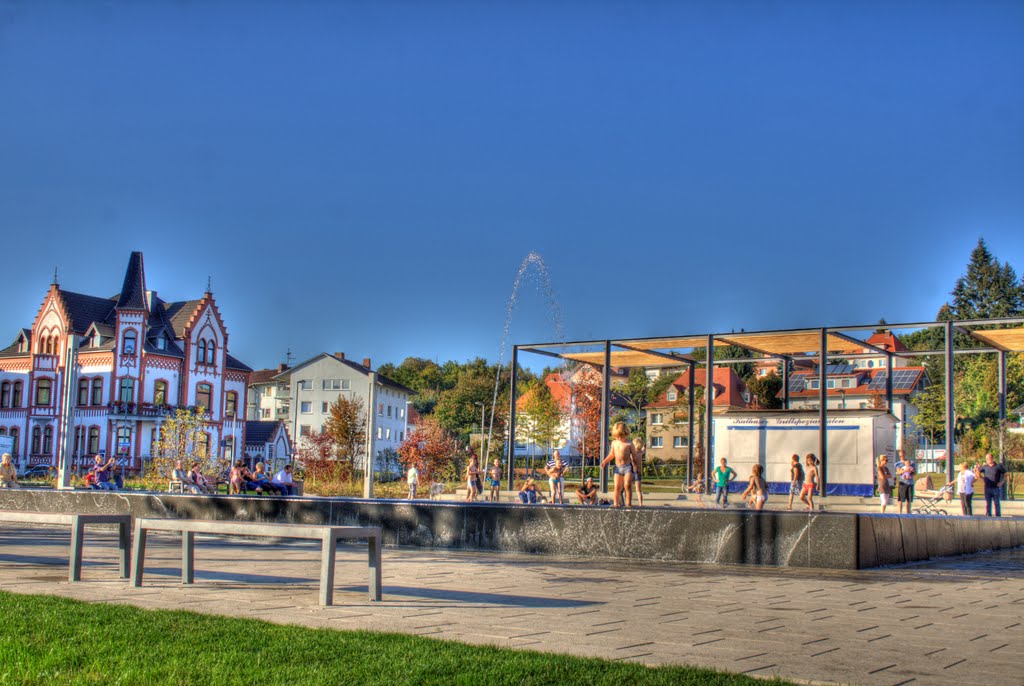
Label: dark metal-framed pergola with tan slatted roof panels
xmin=508 ymin=317 xmax=1024 ymax=495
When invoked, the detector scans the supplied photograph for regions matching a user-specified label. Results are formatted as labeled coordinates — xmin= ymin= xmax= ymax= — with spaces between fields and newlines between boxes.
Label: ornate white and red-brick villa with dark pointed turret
xmin=0 ymin=252 xmax=252 ymax=468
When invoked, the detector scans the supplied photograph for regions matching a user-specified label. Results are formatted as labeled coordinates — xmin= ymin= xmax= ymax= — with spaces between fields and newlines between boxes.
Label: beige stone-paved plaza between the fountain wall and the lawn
xmin=0 ymin=525 xmax=1024 ymax=686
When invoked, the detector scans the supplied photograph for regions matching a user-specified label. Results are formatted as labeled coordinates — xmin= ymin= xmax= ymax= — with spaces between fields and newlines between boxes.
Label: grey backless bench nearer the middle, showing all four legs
xmin=132 ymin=518 xmax=382 ymax=605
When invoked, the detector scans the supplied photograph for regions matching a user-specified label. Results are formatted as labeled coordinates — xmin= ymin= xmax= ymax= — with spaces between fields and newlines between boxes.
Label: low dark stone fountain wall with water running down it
xmin=0 ymin=490 xmax=1024 ymax=569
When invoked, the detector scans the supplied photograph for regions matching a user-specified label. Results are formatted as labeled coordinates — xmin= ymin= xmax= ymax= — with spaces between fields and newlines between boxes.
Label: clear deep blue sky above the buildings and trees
xmin=0 ymin=0 xmax=1024 ymax=367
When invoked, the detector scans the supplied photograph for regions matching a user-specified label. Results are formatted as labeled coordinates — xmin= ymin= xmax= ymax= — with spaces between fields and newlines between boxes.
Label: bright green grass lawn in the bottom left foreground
xmin=0 ymin=592 xmax=784 ymax=686
